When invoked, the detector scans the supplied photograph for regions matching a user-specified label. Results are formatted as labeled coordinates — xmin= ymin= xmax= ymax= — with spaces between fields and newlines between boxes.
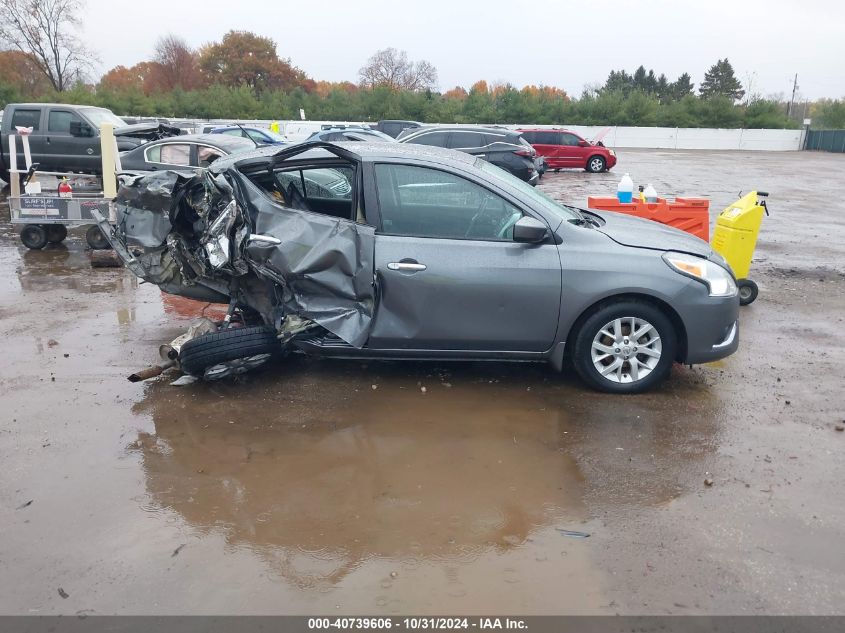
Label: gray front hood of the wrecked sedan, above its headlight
xmin=589 ymin=209 xmax=713 ymax=258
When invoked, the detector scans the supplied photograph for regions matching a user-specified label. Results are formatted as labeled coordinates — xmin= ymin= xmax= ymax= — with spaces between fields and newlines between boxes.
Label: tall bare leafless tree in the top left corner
xmin=0 ymin=0 xmax=95 ymax=92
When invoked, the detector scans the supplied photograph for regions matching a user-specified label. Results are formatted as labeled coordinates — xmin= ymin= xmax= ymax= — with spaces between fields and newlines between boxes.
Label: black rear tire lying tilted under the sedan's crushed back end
xmin=179 ymin=325 xmax=282 ymax=376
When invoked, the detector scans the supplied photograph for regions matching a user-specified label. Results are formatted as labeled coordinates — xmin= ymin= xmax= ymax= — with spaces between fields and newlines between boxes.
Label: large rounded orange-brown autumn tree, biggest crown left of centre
xmin=199 ymin=31 xmax=308 ymax=93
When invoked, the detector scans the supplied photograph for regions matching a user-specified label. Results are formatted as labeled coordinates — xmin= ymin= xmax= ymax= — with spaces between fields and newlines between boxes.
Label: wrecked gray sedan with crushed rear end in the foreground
xmin=95 ymin=142 xmax=739 ymax=393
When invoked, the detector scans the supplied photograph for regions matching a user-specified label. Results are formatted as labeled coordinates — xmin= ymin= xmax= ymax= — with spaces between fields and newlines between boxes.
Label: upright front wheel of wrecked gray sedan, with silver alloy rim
xmin=572 ymin=299 xmax=677 ymax=394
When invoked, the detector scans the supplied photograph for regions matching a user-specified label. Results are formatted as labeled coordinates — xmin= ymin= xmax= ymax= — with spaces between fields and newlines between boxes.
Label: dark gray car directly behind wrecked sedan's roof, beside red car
xmin=397 ymin=126 xmax=540 ymax=185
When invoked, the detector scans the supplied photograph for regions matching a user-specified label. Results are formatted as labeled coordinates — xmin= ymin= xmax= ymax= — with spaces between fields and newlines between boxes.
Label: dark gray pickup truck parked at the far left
xmin=0 ymin=103 xmax=181 ymax=182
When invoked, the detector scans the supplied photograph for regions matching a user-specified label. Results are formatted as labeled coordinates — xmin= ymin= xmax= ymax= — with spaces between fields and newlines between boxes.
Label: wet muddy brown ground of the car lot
xmin=0 ymin=150 xmax=845 ymax=614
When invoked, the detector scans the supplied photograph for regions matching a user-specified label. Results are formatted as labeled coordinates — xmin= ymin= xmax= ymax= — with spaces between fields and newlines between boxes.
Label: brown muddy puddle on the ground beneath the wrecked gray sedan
xmin=134 ymin=359 xmax=718 ymax=612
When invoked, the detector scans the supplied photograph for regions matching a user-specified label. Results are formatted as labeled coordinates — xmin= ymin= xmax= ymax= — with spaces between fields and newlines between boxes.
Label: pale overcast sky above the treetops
xmin=84 ymin=0 xmax=845 ymax=99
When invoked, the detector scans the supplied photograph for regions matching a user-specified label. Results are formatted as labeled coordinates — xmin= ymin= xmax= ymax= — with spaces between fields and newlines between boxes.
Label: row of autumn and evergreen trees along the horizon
xmin=0 ymin=0 xmax=845 ymax=128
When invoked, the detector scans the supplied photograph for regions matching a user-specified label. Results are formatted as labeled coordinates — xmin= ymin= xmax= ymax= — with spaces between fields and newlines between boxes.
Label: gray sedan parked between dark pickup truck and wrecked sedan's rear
xmin=120 ymin=134 xmax=255 ymax=172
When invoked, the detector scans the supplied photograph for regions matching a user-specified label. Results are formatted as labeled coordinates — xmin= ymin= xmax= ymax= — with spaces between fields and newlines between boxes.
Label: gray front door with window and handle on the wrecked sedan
xmin=368 ymin=162 xmax=561 ymax=352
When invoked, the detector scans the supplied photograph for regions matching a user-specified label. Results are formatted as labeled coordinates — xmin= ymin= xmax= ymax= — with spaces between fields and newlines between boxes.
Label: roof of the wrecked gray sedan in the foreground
xmin=209 ymin=137 xmax=478 ymax=171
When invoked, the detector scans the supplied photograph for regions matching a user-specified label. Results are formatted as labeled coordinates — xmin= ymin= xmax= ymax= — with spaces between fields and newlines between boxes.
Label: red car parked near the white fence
xmin=519 ymin=128 xmax=616 ymax=173
